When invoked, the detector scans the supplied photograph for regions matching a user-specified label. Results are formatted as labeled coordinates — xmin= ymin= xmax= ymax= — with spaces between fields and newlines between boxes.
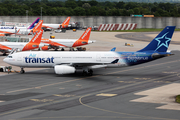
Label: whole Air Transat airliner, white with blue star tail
xmin=3 ymin=26 xmax=175 ymax=75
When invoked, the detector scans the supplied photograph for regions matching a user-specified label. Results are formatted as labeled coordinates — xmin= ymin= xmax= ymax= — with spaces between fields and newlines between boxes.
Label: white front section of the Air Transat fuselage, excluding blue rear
xmin=4 ymin=51 xmax=126 ymax=68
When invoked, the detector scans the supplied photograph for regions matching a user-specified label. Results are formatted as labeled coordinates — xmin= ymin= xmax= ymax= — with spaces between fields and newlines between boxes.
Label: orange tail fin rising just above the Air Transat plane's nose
xmin=22 ymin=29 xmax=43 ymax=51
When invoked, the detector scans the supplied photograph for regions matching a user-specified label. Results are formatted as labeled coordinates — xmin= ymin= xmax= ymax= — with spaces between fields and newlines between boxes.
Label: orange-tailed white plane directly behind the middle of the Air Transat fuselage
xmin=41 ymin=27 xmax=95 ymax=51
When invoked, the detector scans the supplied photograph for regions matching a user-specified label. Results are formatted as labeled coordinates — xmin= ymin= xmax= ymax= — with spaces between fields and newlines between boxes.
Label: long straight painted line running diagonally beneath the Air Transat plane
xmin=6 ymin=60 xmax=180 ymax=93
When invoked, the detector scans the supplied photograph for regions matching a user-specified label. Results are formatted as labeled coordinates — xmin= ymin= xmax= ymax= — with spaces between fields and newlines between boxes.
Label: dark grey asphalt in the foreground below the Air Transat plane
xmin=0 ymin=51 xmax=180 ymax=120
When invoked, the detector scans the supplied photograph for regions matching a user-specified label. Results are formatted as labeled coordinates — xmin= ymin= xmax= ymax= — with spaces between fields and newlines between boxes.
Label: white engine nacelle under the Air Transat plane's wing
xmin=54 ymin=65 xmax=76 ymax=75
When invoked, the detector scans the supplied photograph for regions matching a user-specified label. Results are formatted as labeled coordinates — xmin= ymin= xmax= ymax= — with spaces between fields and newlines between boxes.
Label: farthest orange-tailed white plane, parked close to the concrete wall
xmin=42 ymin=17 xmax=71 ymax=31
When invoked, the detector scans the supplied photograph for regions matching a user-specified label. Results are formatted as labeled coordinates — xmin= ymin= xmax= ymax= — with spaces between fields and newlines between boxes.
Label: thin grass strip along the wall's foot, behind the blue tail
xmin=95 ymin=28 xmax=180 ymax=32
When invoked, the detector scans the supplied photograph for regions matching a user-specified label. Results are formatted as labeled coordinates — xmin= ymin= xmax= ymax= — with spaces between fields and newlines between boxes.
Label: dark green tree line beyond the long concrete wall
xmin=0 ymin=0 xmax=180 ymax=17
